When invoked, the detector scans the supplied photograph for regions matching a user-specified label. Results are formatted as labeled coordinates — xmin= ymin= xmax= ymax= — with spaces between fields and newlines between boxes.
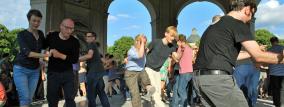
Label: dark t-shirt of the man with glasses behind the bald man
xmin=87 ymin=43 xmax=105 ymax=77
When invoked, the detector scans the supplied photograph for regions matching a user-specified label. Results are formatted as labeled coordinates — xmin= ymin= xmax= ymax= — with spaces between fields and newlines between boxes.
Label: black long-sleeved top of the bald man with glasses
xmin=46 ymin=32 xmax=80 ymax=72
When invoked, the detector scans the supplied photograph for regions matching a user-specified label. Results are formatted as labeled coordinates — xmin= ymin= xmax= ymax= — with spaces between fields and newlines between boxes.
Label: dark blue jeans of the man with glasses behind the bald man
xmin=87 ymin=72 xmax=110 ymax=107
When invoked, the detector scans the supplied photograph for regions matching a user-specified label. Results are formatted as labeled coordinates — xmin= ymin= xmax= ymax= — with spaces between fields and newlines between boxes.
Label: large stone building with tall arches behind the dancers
xmin=30 ymin=0 xmax=260 ymax=52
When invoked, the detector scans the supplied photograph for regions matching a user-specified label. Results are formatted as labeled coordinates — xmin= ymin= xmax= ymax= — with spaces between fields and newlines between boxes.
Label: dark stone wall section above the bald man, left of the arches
xmin=30 ymin=0 xmax=112 ymax=53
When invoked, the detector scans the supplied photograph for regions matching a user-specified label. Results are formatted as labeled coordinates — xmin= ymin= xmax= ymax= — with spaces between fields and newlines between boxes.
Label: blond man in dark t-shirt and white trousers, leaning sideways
xmin=145 ymin=26 xmax=178 ymax=107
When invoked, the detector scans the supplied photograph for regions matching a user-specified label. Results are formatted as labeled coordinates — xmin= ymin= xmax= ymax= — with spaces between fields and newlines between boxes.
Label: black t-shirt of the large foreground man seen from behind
xmin=194 ymin=16 xmax=254 ymax=73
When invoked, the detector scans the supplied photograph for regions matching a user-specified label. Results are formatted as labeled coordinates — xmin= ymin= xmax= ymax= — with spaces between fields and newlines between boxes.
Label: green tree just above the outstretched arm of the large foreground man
xmin=255 ymin=29 xmax=275 ymax=47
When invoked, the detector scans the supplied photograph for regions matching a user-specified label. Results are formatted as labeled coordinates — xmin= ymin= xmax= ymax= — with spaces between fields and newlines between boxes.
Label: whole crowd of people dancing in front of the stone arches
xmin=0 ymin=0 xmax=284 ymax=107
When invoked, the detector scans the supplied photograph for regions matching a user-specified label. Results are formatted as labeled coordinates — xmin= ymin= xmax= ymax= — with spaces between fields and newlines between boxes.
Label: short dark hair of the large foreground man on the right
xmin=230 ymin=0 xmax=257 ymax=12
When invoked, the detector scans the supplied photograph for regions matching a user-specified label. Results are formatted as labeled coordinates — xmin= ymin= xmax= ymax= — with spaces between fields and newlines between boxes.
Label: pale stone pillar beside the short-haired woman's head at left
xmin=30 ymin=0 xmax=47 ymax=33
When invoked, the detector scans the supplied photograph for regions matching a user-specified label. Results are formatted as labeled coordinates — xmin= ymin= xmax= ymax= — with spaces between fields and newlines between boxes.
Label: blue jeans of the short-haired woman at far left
xmin=13 ymin=65 xmax=39 ymax=106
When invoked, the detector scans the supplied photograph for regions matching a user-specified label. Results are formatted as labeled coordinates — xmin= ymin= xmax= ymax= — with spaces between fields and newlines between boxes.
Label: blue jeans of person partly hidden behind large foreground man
xmin=233 ymin=64 xmax=260 ymax=107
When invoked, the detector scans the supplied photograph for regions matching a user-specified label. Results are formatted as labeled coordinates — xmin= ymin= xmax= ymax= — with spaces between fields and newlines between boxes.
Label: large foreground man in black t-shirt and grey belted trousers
xmin=194 ymin=0 xmax=283 ymax=107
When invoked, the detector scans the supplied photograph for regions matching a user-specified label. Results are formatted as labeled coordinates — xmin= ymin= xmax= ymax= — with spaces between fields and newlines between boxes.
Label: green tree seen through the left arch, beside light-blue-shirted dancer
xmin=107 ymin=36 xmax=134 ymax=61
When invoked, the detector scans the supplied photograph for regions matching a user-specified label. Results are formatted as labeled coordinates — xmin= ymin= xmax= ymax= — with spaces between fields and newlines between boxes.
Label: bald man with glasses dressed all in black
xmin=46 ymin=18 xmax=79 ymax=107
